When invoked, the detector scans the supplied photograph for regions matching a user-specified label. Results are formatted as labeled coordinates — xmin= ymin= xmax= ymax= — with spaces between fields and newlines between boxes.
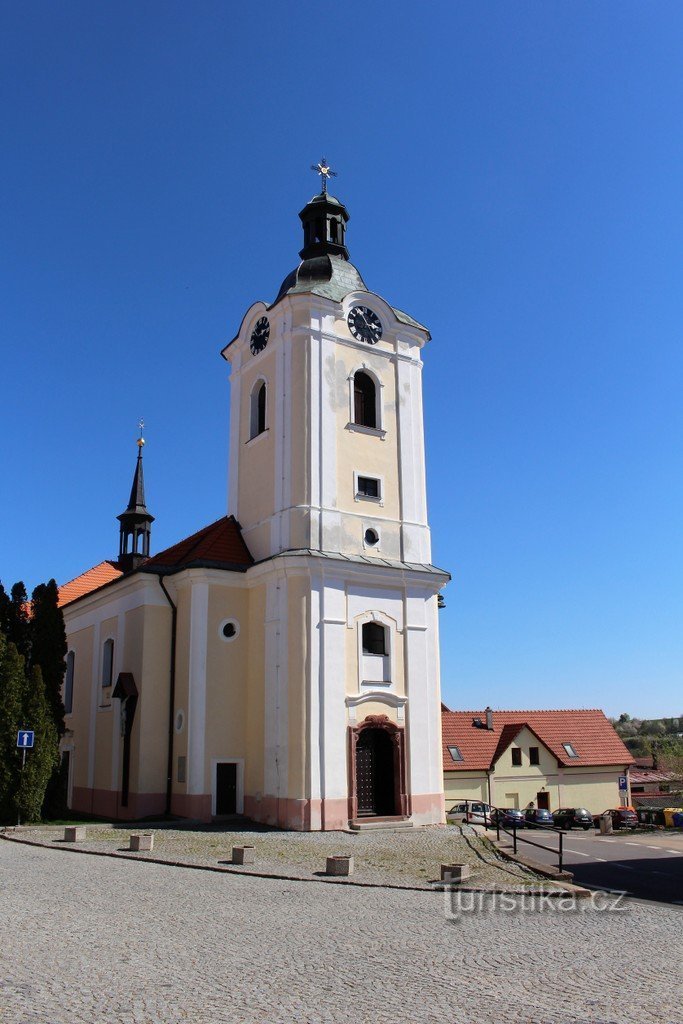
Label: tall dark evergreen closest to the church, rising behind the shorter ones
xmin=31 ymin=580 xmax=67 ymax=736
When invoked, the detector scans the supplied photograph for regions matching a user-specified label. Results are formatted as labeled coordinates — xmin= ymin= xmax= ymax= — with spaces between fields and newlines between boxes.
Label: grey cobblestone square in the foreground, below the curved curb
xmin=0 ymin=842 xmax=683 ymax=1024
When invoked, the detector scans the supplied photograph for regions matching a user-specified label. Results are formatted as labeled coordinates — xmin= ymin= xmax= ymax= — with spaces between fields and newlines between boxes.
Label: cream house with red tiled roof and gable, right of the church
xmin=441 ymin=706 xmax=633 ymax=814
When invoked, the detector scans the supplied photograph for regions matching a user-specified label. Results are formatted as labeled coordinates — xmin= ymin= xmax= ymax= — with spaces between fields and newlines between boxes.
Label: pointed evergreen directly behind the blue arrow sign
xmin=15 ymin=666 xmax=59 ymax=821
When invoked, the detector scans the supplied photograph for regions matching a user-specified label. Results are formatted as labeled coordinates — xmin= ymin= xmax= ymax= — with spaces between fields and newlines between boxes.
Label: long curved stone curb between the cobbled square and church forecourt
xmin=0 ymin=831 xmax=590 ymax=897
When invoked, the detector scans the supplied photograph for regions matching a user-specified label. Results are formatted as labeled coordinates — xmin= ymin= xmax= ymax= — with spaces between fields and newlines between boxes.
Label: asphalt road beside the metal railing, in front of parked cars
xmin=497 ymin=828 xmax=683 ymax=906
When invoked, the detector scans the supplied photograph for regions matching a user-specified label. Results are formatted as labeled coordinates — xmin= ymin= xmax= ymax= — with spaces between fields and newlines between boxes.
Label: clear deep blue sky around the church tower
xmin=0 ymin=0 xmax=683 ymax=716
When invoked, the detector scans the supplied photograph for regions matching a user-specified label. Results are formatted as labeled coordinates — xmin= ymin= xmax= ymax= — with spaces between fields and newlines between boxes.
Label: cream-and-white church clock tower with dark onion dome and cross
xmin=222 ymin=161 xmax=449 ymax=828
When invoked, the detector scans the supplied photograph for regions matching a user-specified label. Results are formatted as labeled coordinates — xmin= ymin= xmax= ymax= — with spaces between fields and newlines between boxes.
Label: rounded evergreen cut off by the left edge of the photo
xmin=0 ymin=633 xmax=26 ymax=822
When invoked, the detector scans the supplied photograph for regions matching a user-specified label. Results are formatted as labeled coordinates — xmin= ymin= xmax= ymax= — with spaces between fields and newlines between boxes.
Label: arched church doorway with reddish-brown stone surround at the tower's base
xmin=349 ymin=715 xmax=410 ymax=820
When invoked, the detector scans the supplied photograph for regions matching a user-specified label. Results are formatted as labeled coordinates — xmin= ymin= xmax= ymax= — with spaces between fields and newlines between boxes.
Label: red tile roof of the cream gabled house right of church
xmin=441 ymin=710 xmax=633 ymax=771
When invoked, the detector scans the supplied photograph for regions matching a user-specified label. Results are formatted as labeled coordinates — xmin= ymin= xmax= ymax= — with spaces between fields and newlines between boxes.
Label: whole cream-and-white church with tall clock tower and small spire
xmin=60 ymin=160 xmax=450 ymax=830
